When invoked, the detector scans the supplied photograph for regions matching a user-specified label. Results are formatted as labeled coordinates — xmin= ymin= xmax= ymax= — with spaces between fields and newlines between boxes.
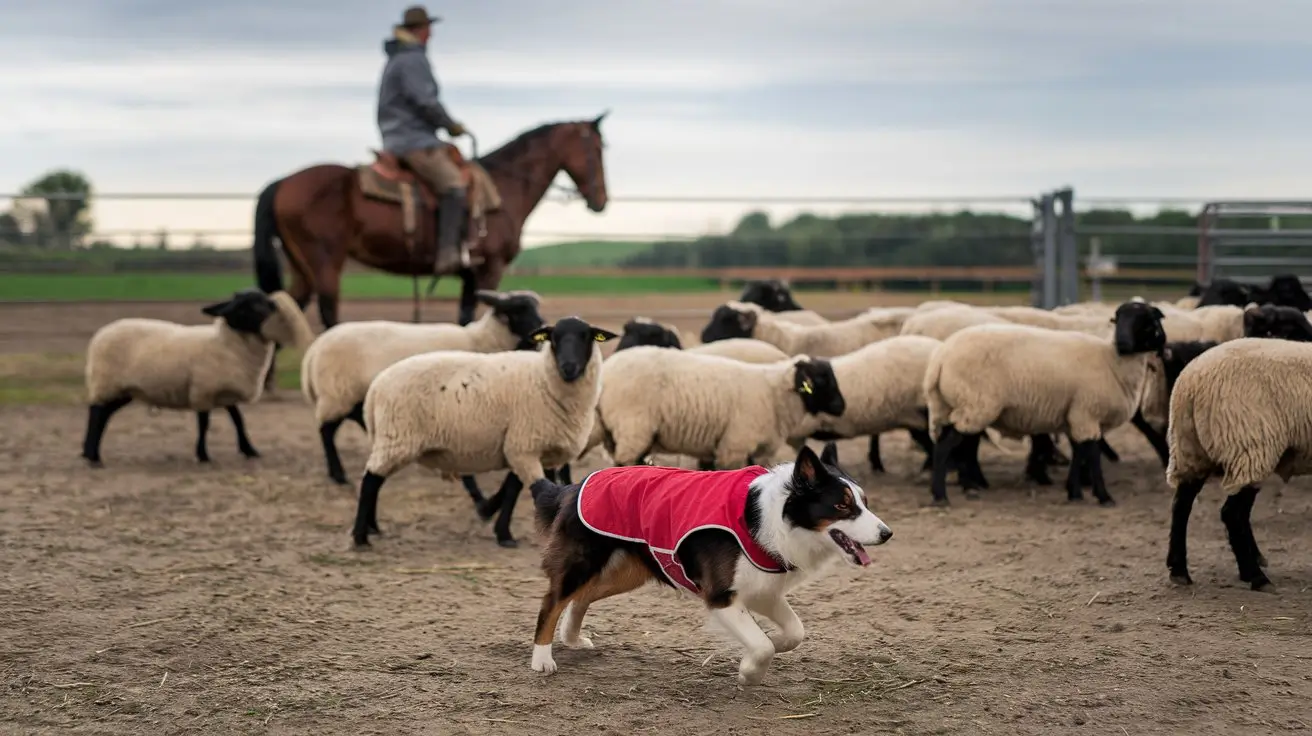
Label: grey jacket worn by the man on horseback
xmin=378 ymin=38 xmax=455 ymax=156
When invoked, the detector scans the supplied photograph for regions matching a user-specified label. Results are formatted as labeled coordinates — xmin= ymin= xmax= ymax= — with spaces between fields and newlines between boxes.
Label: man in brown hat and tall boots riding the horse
xmin=378 ymin=5 xmax=477 ymax=273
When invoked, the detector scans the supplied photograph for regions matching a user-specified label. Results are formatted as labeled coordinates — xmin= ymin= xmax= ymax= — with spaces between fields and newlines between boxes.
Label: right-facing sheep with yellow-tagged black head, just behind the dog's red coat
xmin=597 ymin=346 xmax=845 ymax=470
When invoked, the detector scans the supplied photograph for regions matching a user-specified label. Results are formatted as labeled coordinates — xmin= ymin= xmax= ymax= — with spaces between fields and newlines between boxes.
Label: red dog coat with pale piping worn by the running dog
xmin=579 ymin=466 xmax=785 ymax=594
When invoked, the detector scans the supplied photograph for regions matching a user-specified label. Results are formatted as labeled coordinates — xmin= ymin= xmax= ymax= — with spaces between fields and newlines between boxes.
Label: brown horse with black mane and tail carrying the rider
xmin=255 ymin=113 xmax=606 ymax=334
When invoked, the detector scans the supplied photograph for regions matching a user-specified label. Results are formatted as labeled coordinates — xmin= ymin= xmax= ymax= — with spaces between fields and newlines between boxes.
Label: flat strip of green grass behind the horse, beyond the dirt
xmin=0 ymin=273 xmax=719 ymax=302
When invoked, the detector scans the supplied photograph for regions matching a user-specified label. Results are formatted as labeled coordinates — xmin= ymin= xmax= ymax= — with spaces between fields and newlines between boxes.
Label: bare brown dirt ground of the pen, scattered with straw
xmin=0 ymin=295 xmax=1312 ymax=736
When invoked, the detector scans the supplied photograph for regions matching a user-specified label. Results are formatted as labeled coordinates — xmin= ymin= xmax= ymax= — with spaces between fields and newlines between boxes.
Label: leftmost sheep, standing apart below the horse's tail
xmin=81 ymin=290 xmax=314 ymax=467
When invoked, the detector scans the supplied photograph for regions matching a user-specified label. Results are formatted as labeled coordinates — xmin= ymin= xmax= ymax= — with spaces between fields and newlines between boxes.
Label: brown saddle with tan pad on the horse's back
xmin=356 ymin=146 xmax=496 ymax=265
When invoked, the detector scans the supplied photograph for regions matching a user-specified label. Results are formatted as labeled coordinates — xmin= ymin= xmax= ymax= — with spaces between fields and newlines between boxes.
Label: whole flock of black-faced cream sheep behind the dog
xmin=83 ymin=276 xmax=1312 ymax=589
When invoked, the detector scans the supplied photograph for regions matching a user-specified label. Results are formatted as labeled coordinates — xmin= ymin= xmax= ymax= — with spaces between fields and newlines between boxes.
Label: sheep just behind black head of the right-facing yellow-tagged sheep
xmin=811 ymin=335 xmax=942 ymax=472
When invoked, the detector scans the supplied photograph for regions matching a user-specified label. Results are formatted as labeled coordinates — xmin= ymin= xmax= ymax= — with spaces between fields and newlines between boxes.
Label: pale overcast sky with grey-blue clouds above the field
xmin=0 ymin=0 xmax=1312 ymax=246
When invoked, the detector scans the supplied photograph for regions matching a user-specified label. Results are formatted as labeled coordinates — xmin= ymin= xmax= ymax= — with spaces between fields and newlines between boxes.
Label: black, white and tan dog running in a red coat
xmin=530 ymin=442 xmax=893 ymax=685
